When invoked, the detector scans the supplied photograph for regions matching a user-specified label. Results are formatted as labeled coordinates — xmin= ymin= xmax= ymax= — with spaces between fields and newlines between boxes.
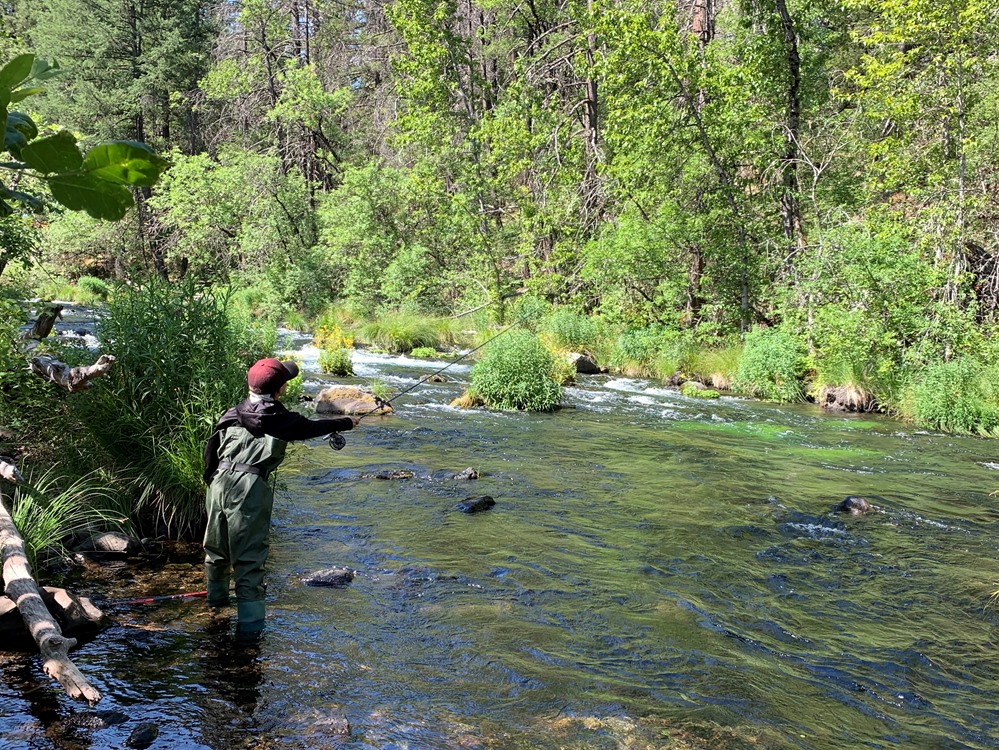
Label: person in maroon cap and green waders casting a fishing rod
xmin=204 ymin=358 xmax=360 ymax=634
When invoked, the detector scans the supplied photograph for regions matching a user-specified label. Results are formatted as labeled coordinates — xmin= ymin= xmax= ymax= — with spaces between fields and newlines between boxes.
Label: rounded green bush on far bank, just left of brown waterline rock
xmin=734 ymin=328 xmax=806 ymax=401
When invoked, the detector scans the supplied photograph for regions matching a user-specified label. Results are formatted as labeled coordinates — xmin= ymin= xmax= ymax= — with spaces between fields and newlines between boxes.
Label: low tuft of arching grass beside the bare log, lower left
xmin=11 ymin=469 xmax=127 ymax=569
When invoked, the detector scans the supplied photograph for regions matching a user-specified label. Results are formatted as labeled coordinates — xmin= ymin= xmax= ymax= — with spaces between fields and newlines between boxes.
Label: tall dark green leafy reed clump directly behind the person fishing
xmin=70 ymin=281 xmax=274 ymax=534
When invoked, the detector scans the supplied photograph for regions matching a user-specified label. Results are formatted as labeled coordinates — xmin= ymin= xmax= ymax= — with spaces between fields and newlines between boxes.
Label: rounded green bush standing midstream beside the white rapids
xmin=472 ymin=330 xmax=562 ymax=411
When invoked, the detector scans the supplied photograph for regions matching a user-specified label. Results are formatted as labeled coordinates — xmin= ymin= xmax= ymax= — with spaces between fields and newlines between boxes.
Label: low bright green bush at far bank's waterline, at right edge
xmin=903 ymin=357 xmax=999 ymax=436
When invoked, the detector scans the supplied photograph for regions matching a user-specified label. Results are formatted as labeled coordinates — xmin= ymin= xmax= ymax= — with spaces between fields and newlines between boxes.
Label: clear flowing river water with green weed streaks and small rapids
xmin=0 ymin=326 xmax=999 ymax=750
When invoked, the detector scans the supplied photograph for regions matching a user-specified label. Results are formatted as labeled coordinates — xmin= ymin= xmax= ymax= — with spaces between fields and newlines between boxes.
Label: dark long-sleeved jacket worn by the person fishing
xmin=204 ymin=398 xmax=354 ymax=484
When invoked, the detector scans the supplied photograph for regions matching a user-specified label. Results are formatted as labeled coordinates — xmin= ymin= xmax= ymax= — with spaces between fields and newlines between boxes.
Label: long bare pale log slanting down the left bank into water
xmin=0 ymin=461 xmax=101 ymax=703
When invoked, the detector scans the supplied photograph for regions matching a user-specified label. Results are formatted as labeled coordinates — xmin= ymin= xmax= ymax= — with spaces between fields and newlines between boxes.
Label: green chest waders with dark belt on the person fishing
xmin=205 ymin=426 xmax=288 ymax=632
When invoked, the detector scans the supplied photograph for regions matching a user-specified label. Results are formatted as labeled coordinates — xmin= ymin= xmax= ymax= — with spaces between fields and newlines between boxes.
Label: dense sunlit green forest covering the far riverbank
xmin=0 ymin=0 xmax=999 ymax=424
